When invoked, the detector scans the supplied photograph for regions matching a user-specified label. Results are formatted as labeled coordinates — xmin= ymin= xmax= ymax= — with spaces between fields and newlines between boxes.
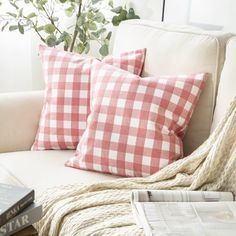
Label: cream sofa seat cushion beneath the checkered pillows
xmin=0 ymin=151 xmax=118 ymax=195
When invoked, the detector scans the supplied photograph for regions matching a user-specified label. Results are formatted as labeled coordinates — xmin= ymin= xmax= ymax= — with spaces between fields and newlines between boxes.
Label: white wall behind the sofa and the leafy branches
xmin=0 ymin=0 xmax=236 ymax=92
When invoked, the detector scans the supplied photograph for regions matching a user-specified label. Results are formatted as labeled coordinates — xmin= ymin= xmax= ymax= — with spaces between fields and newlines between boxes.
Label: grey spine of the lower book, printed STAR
xmin=0 ymin=204 xmax=42 ymax=236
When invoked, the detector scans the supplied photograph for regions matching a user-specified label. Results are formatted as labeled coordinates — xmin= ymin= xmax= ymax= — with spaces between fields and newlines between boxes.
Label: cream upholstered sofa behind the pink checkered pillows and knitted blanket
xmin=0 ymin=20 xmax=236 ymax=196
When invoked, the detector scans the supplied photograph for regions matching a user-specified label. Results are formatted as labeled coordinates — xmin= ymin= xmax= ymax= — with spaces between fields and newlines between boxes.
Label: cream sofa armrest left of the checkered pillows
xmin=0 ymin=91 xmax=43 ymax=153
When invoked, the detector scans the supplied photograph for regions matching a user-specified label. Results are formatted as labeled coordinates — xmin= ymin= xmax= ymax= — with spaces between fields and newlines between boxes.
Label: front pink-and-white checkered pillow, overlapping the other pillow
xmin=65 ymin=61 xmax=207 ymax=176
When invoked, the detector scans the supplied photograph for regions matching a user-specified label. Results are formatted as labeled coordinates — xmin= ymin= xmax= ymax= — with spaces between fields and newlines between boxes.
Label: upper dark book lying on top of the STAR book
xmin=0 ymin=183 xmax=34 ymax=226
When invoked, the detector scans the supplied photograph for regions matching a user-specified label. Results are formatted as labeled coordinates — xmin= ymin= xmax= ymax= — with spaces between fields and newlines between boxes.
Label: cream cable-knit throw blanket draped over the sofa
xmin=36 ymin=98 xmax=236 ymax=236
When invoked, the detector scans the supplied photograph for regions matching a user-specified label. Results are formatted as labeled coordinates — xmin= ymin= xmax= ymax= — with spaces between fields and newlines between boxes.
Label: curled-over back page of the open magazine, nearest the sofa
xmin=131 ymin=190 xmax=234 ymax=202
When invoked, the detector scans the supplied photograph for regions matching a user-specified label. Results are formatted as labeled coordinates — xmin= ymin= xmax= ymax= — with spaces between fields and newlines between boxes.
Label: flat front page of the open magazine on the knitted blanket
xmin=135 ymin=202 xmax=236 ymax=236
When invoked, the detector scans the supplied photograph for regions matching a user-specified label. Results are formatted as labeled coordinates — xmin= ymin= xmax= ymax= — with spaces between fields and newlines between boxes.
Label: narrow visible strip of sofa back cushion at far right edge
xmin=212 ymin=37 xmax=236 ymax=131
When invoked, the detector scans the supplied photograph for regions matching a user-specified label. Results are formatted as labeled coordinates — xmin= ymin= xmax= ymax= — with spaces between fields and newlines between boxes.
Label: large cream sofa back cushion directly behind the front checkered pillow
xmin=113 ymin=20 xmax=231 ymax=155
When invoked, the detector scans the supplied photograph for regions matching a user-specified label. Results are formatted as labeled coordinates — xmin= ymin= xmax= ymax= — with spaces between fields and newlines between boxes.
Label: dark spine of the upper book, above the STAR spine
xmin=0 ymin=190 xmax=34 ymax=226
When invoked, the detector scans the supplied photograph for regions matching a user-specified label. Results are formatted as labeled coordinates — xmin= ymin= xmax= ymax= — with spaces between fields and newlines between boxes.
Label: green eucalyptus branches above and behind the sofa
xmin=0 ymin=0 xmax=139 ymax=56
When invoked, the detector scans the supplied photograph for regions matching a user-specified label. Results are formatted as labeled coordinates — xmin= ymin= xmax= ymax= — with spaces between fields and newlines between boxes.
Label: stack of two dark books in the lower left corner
xmin=0 ymin=183 xmax=42 ymax=236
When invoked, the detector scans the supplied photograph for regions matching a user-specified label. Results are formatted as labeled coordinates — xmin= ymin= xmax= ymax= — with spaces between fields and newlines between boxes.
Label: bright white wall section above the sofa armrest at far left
xmin=0 ymin=32 xmax=32 ymax=92
